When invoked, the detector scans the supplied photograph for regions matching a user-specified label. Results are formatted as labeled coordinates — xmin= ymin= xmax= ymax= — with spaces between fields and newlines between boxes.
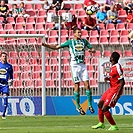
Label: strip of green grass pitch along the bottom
xmin=0 ymin=115 xmax=133 ymax=133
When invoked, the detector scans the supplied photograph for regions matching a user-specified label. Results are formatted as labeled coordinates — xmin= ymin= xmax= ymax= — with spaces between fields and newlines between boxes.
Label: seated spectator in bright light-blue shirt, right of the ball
xmin=96 ymin=6 xmax=107 ymax=23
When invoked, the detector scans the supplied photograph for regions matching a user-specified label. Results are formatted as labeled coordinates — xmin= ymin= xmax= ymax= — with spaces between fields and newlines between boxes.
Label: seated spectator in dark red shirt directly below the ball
xmin=84 ymin=15 xmax=100 ymax=33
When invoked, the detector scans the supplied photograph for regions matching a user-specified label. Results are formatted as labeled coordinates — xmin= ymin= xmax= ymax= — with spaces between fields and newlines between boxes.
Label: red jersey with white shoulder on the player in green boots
xmin=109 ymin=63 xmax=124 ymax=92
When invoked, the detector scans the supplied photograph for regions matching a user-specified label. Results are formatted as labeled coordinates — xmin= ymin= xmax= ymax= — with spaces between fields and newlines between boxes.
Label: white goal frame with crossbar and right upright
xmin=0 ymin=34 xmax=46 ymax=115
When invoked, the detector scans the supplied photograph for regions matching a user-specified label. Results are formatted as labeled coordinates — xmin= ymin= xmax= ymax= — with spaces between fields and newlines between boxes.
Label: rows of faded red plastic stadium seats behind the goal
xmin=0 ymin=0 xmax=133 ymax=95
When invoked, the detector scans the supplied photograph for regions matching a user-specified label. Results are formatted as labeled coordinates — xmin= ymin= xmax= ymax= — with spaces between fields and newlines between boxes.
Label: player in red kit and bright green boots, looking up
xmin=92 ymin=52 xmax=125 ymax=130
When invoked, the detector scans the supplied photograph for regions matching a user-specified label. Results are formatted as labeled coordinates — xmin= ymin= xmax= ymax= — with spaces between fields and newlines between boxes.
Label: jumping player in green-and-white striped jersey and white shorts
xmin=42 ymin=28 xmax=95 ymax=115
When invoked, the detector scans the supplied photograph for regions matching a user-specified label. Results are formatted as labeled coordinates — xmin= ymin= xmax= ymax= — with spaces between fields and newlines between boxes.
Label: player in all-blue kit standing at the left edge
xmin=0 ymin=52 xmax=13 ymax=119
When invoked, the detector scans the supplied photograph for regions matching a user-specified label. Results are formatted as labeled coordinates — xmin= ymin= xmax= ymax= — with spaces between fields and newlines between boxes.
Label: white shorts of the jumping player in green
xmin=71 ymin=63 xmax=89 ymax=83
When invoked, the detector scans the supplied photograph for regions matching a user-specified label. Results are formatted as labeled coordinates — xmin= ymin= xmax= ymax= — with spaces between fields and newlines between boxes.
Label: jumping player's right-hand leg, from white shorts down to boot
xmin=80 ymin=64 xmax=95 ymax=113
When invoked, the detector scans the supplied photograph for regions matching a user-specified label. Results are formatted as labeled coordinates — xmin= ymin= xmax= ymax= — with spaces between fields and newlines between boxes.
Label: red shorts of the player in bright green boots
xmin=101 ymin=88 xmax=120 ymax=107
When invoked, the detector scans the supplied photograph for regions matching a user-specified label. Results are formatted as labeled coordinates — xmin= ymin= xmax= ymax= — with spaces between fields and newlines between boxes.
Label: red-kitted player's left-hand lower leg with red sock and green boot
xmin=92 ymin=99 xmax=105 ymax=129
